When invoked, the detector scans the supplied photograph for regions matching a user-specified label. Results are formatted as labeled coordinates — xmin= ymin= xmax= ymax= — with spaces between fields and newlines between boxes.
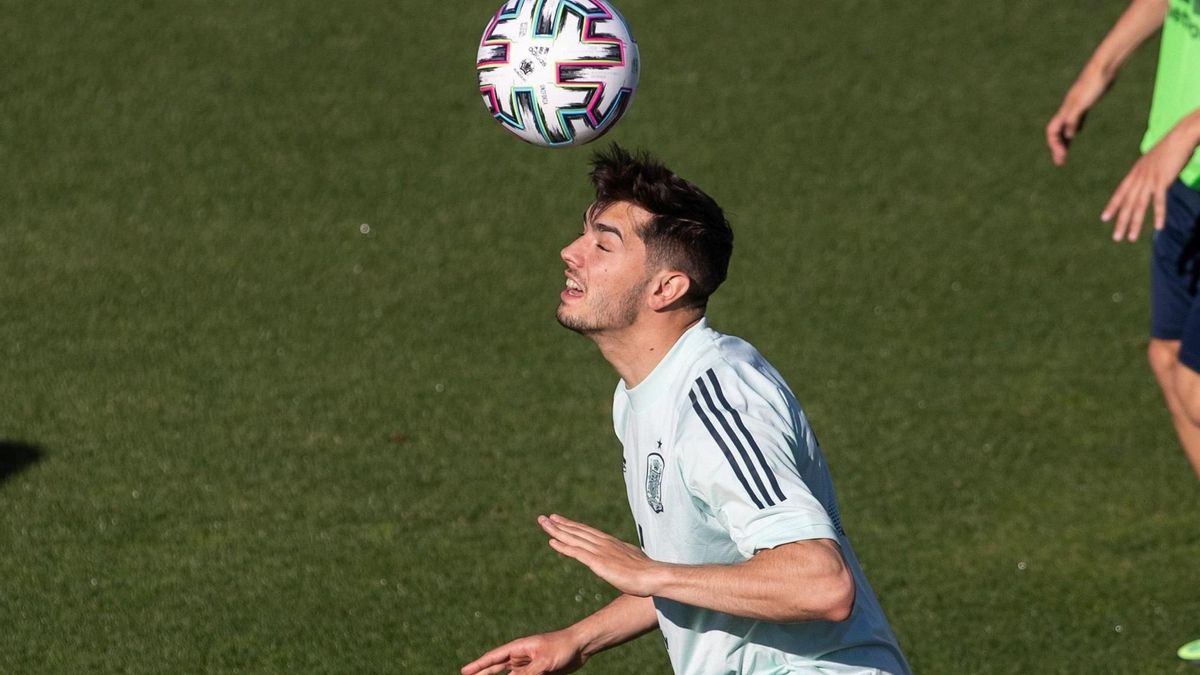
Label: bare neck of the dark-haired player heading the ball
xmin=590 ymin=312 xmax=704 ymax=389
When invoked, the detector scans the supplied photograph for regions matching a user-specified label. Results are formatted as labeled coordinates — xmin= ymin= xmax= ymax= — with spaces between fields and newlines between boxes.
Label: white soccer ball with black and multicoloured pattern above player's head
xmin=475 ymin=0 xmax=638 ymax=148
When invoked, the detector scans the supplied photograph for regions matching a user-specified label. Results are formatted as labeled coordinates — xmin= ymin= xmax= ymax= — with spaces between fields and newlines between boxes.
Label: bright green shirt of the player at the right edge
xmin=1141 ymin=0 xmax=1200 ymax=187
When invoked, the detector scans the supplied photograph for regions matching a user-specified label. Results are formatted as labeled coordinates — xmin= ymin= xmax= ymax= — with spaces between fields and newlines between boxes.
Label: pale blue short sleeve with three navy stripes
xmin=676 ymin=370 xmax=838 ymax=558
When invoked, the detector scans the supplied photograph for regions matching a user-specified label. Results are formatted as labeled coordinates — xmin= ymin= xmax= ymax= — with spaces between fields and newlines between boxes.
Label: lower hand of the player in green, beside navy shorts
xmin=1100 ymin=127 xmax=1195 ymax=241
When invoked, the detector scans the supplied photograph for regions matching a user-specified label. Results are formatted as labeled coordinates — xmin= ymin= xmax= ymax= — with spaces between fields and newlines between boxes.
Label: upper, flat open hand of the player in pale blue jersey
xmin=538 ymin=515 xmax=662 ymax=597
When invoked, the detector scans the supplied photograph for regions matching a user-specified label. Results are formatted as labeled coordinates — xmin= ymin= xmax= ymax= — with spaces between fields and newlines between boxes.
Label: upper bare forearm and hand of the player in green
xmin=1046 ymin=0 xmax=1168 ymax=165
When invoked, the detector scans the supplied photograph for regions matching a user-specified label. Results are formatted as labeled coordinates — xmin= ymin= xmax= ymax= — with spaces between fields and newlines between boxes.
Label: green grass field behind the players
xmin=0 ymin=0 xmax=1200 ymax=674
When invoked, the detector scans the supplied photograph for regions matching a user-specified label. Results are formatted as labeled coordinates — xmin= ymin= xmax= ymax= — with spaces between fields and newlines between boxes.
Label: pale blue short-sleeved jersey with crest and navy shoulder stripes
xmin=613 ymin=319 xmax=908 ymax=675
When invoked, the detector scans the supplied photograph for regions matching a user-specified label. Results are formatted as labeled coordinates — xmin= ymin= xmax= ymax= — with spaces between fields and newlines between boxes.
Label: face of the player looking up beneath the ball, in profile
xmin=558 ymin=202 xmax=652 ymax=334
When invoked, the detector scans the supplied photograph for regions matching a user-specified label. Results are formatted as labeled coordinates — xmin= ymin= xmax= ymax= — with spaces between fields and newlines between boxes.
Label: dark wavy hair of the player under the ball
xmin=589 ymin=143 xmax=733 ymax=309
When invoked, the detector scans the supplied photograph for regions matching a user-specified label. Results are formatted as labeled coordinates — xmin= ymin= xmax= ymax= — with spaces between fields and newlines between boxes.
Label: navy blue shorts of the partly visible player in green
xmin=1150 ymin=180 xmax=1200 ymax=372
